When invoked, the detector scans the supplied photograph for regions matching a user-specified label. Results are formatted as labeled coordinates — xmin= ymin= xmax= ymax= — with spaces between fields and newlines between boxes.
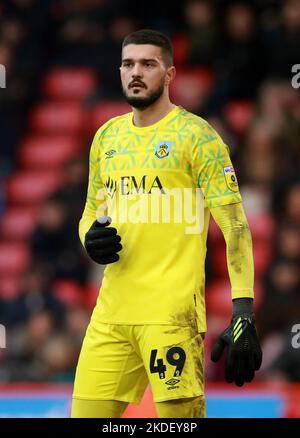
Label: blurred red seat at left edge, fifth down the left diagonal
xmin=0 ymin=207 xmax=38 ymax=241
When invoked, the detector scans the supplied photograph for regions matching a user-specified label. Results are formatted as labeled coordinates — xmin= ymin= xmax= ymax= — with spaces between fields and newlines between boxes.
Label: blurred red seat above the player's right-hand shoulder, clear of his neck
xmin=224 ymin=101 xmax=254 ymax=135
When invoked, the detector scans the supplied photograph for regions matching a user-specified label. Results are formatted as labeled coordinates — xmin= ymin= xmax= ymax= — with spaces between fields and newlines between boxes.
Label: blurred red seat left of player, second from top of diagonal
xmin=29 ymin=102 xmax=86 ymax=135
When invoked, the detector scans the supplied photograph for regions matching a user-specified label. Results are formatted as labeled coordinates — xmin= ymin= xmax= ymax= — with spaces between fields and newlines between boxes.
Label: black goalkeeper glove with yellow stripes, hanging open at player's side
xmin=211 ymin=316 xmax=262 ymax=386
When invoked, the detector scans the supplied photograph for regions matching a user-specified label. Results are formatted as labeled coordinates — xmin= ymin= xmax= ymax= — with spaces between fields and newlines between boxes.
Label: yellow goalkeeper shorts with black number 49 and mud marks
xmin=73 ymin=319 xmax=204 ymax=404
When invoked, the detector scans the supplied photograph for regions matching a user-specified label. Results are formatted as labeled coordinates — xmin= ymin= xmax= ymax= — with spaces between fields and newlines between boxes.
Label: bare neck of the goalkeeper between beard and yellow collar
xmin=132 ymin=98 xmax=175 ymax=128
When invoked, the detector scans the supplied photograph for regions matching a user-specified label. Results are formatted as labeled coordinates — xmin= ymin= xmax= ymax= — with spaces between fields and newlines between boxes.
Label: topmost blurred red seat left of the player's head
xmin=42 ymin=67 xmax=97 ymax=100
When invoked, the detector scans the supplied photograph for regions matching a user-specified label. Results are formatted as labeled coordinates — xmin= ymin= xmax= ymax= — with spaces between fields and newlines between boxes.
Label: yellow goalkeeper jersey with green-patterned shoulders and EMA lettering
xmin=79 ymin=106 xmax=241 ymax=332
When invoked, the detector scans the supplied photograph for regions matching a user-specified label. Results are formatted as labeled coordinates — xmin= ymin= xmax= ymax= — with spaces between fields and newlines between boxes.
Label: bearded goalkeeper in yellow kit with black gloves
xmin=72 ymin=30 xmax=262 ymax=418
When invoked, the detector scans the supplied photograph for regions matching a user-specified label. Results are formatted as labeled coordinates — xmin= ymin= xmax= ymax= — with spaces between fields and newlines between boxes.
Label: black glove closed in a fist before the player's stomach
xmin=84 ymin=216 xmax=122 ymax=265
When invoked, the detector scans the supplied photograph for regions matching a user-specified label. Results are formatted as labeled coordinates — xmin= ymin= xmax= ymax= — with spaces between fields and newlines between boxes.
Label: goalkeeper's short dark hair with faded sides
xmin=122 ymin=29 xmax=173 ymax=66
